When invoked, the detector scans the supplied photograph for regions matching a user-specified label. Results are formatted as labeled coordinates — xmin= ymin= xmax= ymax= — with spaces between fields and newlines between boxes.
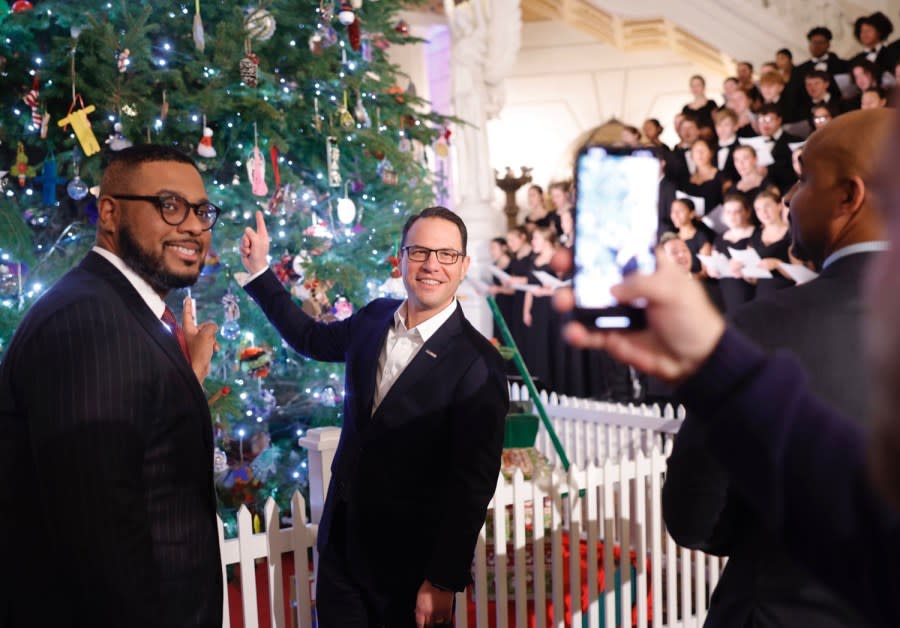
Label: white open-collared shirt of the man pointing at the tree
xmin=372 ymin=299 xmax=459 ymax=414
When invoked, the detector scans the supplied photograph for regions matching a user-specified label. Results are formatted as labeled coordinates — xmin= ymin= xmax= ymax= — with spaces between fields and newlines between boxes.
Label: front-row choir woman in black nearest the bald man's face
xmin=750 ymin=190 xmax=799 ymax=299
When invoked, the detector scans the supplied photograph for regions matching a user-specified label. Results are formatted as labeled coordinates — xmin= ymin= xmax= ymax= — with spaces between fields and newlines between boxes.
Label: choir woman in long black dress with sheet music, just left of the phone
xmin=522 ymin=227 xmax=565 ymax=392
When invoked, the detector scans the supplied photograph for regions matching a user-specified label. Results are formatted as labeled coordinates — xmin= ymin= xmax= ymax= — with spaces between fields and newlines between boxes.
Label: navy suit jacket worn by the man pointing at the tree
xmin=245 ymin=271 xmax=509 ymax=593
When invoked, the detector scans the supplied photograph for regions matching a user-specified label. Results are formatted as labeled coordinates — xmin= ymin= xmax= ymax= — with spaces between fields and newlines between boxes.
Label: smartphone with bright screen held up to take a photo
xmin=572 ymin=146 xmax=660 ymax=329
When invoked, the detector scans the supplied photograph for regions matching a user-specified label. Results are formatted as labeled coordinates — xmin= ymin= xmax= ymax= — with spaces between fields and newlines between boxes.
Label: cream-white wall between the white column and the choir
xmin=488 ymin=21 xmax=725 ymax=222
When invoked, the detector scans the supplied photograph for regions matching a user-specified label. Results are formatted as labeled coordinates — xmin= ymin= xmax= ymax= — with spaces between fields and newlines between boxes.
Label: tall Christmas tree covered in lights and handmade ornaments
xmin=0 ymin=0 xmax=449 ymax=520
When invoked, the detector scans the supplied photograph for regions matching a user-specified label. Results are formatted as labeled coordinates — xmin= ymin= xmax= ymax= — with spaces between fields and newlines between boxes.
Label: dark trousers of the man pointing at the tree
xmin=316 ymin=502 xmax=421 ymax=628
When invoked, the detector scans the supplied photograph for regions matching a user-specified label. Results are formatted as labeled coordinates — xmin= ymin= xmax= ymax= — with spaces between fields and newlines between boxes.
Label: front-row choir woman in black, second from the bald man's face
xmin=707 ymin=194 xmax=756 ymax=315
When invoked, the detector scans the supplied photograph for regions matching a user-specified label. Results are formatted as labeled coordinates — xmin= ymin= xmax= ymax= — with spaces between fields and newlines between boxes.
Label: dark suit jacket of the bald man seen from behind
xmin=663 ymin=253 xmax=878 ymax=628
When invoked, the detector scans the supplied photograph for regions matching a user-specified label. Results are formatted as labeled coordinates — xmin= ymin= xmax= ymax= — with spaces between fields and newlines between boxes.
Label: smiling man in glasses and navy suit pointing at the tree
xmin=241 ymin=207 xmax=509 ymax=628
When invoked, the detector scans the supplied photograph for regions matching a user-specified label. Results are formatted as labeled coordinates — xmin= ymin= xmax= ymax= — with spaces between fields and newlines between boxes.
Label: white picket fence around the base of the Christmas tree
xmin=220 ymin=389 xmax=722 ymax=628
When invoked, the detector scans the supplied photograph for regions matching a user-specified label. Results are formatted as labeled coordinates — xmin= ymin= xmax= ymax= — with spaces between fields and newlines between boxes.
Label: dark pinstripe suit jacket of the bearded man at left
xmin=0 ymin=253 xmax=222 ymax=628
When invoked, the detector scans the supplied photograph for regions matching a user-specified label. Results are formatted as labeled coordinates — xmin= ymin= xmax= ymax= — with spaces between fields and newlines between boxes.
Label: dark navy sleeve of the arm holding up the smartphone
xmin=677 ymin=329 xmax=900 ymax=627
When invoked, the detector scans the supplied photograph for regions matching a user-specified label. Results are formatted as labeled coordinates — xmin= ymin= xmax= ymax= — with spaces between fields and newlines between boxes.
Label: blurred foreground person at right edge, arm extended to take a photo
xmin=558 ymin=105 xmax=900 ymax=625
